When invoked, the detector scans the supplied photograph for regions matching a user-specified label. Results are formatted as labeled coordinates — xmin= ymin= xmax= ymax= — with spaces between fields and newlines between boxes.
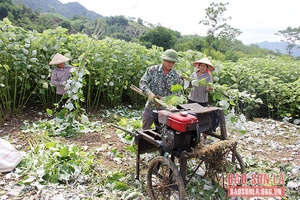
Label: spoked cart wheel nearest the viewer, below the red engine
xmin=147 ymin=156 xmax=185 ymax=200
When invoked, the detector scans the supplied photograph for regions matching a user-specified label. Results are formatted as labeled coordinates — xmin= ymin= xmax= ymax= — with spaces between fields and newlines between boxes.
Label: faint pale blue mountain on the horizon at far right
xmin=254 ymin=41 xmax=300 ymax=57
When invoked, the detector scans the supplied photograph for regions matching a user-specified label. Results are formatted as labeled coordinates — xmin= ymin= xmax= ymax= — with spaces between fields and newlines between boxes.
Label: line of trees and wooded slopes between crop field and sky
xmin=0 ymin=0 xmax=299 ymax=61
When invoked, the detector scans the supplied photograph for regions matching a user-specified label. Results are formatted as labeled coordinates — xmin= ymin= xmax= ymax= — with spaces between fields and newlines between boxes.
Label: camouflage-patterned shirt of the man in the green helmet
xmin=139 ymin=64 xmax=182 ymax=110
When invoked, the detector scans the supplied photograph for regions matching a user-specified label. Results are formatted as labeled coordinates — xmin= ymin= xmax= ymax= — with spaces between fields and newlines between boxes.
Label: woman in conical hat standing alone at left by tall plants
xmin=49 ymin=53 xmax=73 ymax=109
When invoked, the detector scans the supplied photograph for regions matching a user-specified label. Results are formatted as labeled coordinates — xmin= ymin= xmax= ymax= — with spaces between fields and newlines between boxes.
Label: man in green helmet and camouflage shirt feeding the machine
xmin=139 ymin=49 xmax=182 ymax=130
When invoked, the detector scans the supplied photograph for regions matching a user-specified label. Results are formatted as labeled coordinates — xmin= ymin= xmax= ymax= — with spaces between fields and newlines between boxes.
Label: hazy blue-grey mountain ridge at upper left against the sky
xmin=13 ymin=0 xmax=103 ymax=20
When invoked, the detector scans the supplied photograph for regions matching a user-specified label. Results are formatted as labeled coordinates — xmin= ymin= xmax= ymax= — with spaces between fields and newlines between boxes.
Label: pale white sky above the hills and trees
xmin=59 ymin=0 xmax=300 ymax=44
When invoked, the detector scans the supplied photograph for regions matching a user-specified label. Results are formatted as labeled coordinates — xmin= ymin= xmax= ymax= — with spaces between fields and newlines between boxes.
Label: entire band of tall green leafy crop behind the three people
xmin=0 ymin=19 xmax=300 ymax=126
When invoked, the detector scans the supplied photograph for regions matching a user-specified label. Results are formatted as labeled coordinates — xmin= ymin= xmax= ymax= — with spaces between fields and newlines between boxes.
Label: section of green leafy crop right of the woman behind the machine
xmin=214 ymin=57 xmax=300 ymax=119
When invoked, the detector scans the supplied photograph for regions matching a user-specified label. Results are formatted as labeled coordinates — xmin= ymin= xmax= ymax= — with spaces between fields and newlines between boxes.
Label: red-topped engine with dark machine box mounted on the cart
xmin=153 ymin=104 xmax=220 ymax=152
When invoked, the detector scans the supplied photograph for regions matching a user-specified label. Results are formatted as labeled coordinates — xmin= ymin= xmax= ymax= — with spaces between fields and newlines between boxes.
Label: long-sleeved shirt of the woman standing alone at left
xmin=51 ymin=65 xmax=73 ymax=95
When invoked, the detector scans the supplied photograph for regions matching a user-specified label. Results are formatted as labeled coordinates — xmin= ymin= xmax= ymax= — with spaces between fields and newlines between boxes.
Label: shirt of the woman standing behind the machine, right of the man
xmin=188 ymin=72 xmax=212 ymax=103
